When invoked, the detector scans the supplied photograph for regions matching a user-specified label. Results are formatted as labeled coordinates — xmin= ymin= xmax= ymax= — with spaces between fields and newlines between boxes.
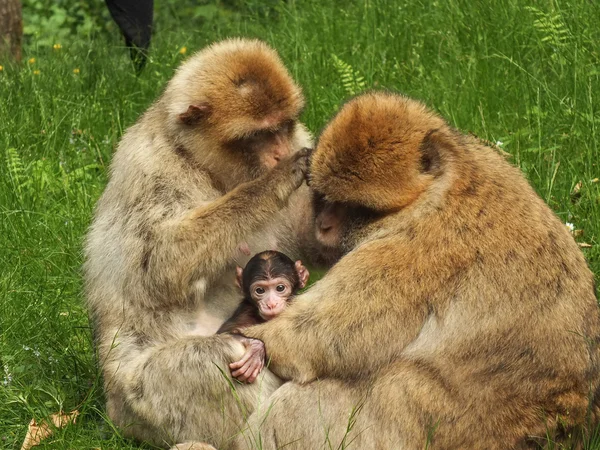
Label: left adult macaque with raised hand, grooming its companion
xmin=85 ymin=39 xmax=313 ymax=448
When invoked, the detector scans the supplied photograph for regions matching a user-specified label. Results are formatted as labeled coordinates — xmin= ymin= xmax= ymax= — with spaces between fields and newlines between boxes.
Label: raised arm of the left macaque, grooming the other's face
xmin=145 ymin=151 xmax=308 ymax=301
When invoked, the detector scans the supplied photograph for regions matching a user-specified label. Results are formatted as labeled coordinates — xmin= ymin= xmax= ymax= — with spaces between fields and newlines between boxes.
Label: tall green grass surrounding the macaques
xmin=0 ymin=0 xmax=600 ymax=449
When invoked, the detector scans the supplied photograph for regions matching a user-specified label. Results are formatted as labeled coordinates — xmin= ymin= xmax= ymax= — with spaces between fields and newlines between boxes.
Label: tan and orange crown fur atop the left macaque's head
xmin=163 ymin=39 xmax=304 ymax=140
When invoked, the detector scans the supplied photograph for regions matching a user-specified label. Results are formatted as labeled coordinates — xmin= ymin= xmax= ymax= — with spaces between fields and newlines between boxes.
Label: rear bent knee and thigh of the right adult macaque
xmin=365 ymin=359 xmax=548 ymax=450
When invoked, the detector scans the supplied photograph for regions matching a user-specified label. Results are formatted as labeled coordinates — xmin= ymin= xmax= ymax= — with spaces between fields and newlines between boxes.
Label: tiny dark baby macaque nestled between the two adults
xmin=217 ymin=250 xmax=310 ymax=334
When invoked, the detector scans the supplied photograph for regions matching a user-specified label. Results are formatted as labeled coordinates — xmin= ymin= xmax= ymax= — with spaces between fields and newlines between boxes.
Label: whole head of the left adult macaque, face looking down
xmin=163 ymin=39 xmax=310 ymax=184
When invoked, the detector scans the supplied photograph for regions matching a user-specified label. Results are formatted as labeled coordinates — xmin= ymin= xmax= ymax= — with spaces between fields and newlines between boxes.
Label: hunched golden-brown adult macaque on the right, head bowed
xmin=236 ymin=93 xmax=600 ymax=450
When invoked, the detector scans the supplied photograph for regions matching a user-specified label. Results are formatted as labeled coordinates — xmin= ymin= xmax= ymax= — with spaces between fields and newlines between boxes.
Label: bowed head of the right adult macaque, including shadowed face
xmin=310 ymin=92 xmax=453 ymax=262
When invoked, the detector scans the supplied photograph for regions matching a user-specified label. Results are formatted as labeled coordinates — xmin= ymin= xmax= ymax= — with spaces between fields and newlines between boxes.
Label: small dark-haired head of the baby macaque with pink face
xmin=237 ymin=250 xmax=309 ymax=320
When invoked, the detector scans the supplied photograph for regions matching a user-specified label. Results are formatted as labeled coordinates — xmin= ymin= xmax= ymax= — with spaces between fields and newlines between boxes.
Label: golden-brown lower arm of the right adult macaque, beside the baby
xmin=244 ymin=246 xmax=429 ymax=383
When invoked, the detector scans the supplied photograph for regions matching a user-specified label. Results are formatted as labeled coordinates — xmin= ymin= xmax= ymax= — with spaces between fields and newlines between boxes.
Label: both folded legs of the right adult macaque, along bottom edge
xmin=233 ymin=361 xmax=543 ymax=450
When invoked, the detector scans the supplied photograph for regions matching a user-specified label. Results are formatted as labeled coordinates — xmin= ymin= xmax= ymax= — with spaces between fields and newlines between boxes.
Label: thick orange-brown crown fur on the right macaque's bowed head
xmin=311 ymin=92 xmax=451 ymax=210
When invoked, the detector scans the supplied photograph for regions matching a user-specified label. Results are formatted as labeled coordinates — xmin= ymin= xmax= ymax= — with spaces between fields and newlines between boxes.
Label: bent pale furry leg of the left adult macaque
xmin=104 ymin=335 xmax=281 ymax=448
